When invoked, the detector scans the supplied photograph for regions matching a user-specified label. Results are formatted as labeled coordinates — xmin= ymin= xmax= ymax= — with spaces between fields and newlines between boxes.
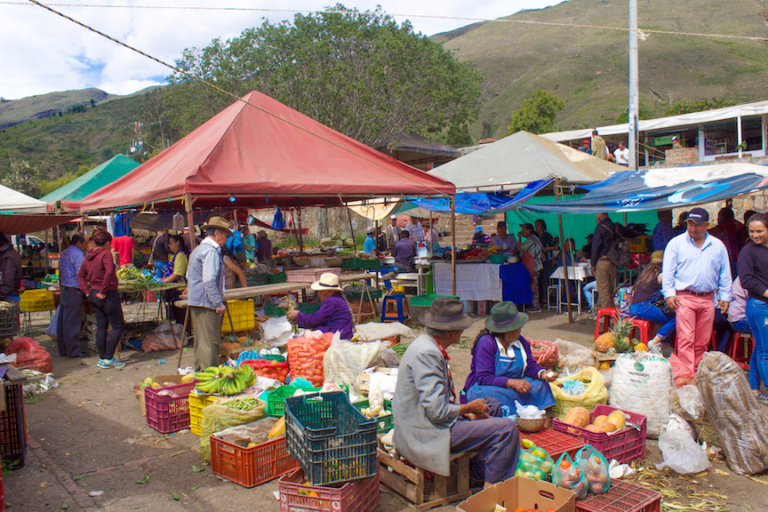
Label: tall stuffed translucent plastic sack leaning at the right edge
xmin=696 ymin=352 xmax=768 ymax=475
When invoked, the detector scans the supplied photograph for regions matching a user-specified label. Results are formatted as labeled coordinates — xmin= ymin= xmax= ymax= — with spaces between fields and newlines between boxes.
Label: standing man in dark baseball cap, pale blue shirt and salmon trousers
xmin=661 ymin=208 xmax=731 ymax=387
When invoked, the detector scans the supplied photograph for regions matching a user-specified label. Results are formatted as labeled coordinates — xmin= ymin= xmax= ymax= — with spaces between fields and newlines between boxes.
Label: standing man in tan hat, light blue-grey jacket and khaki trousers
xmin=187 ymin=217 xmax=232 ymax=370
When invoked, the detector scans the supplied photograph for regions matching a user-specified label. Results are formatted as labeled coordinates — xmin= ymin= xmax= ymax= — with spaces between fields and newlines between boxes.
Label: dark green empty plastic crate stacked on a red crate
xmin=285 ymin=391 xmax=377 ymax=485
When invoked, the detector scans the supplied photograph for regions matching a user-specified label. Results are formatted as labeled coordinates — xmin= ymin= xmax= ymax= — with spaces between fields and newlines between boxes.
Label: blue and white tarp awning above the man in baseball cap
xmin=523 ymin=163 xmax=768 ymax=213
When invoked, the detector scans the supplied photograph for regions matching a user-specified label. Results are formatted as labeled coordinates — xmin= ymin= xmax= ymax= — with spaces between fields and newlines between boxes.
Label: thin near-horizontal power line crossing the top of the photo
xmin=0 ymin=0 xmax=768 ymax=42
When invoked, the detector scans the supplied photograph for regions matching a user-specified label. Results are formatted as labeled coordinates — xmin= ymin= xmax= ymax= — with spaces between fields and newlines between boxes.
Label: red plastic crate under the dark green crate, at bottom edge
xmin=277 ymin=469 xmax=381 ymax=512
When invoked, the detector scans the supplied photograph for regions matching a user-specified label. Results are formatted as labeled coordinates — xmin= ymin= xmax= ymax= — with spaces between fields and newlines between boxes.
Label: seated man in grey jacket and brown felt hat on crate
xmin=392 ymin=297 xmax=520 ymax=486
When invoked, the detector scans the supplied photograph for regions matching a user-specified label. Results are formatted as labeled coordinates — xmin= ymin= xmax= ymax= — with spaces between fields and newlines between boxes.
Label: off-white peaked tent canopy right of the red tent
xmin=430 ymin=132 xmax=626 ymax=192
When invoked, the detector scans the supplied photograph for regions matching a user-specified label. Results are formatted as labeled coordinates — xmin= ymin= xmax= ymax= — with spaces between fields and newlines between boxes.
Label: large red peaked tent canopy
xmin=65 ymin=91 xmax=456 ymax=211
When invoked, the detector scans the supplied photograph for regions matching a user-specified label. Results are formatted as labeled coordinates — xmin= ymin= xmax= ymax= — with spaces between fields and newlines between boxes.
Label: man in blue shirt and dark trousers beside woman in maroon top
xmin=56 ymin=233 xmax=88 ymax=357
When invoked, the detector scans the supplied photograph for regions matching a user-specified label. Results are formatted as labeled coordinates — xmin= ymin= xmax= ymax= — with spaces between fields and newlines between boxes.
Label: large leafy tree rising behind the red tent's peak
xmin=166 ymin=4 xmax=482 ymax=147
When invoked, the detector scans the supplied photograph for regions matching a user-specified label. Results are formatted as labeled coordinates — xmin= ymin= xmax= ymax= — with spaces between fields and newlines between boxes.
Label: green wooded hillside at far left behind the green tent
xmin=0 ymin=95 xmax=144 ymax=178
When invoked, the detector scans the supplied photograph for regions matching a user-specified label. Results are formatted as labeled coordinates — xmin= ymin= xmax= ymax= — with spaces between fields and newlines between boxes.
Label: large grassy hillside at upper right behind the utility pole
xmin=435 ymin=0 xmax=768 ymax=137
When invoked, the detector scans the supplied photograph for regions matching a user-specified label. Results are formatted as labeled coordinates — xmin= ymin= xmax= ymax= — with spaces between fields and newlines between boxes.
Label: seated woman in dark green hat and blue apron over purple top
xmin=464 ymin=302 xmax=556 ymax=411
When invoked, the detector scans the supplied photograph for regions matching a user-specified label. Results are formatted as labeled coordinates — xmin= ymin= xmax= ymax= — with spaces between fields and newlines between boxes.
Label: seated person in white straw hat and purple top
xmin=288 ymin=272 xmax=354 ymax=340
